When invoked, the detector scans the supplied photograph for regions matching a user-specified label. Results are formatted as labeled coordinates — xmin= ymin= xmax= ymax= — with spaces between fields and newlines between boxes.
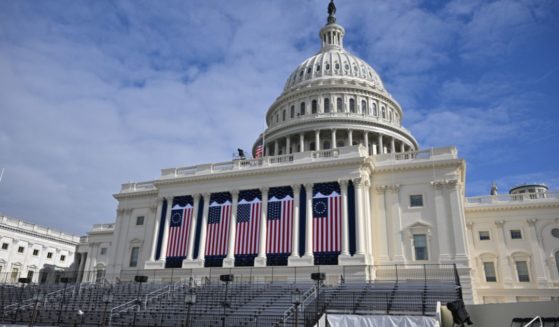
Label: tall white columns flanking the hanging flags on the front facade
xmin=150 ymin=179 xmax=370 ymax=266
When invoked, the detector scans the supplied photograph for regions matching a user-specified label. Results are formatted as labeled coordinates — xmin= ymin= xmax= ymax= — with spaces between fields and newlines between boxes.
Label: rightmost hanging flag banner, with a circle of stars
xmin=313 ymin=183 xmax=342 ymax=253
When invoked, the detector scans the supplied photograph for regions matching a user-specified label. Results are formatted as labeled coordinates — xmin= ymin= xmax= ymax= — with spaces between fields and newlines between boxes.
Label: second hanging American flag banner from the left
xmin=206 ymin=192 xmax=231 ymax=256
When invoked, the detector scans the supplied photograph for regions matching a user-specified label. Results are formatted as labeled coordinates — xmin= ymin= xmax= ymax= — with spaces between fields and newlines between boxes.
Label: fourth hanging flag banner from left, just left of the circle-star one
xmin=266 ymin=187 xmax=293 ymax=254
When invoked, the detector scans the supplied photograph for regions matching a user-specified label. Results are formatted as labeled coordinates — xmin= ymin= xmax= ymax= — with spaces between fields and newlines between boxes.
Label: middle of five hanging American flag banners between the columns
xmin=235 ymin=190 xmax=262 ymax=255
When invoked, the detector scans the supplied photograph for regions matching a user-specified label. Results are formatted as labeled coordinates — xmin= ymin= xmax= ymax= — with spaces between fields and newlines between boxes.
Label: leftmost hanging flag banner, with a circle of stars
xmin=167 ymin=203 xmax=193 ymax=257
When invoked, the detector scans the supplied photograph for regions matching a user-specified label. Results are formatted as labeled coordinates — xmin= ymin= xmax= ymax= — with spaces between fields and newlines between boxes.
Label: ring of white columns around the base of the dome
xmin=264 ymin=129 xmax=412 ymax=156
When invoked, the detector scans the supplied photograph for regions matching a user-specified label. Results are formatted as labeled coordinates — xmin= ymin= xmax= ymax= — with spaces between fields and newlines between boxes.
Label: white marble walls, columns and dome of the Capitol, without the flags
xmin=78 ymin=5 xmax=559 ymax=308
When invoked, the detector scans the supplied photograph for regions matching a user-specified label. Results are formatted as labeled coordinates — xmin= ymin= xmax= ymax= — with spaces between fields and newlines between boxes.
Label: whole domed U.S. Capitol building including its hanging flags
xmin=76 ymin=1 xmax=559 ymax=303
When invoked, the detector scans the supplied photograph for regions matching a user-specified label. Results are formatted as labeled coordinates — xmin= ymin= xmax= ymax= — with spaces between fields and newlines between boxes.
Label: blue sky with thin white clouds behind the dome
xmin=0 ymin=0 xmax=559 ymax=234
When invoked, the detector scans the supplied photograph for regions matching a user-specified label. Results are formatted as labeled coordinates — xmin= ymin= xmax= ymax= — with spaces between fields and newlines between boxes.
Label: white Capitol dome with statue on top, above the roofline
xmin=253 ymin=3 xmax=418 ymax=156
